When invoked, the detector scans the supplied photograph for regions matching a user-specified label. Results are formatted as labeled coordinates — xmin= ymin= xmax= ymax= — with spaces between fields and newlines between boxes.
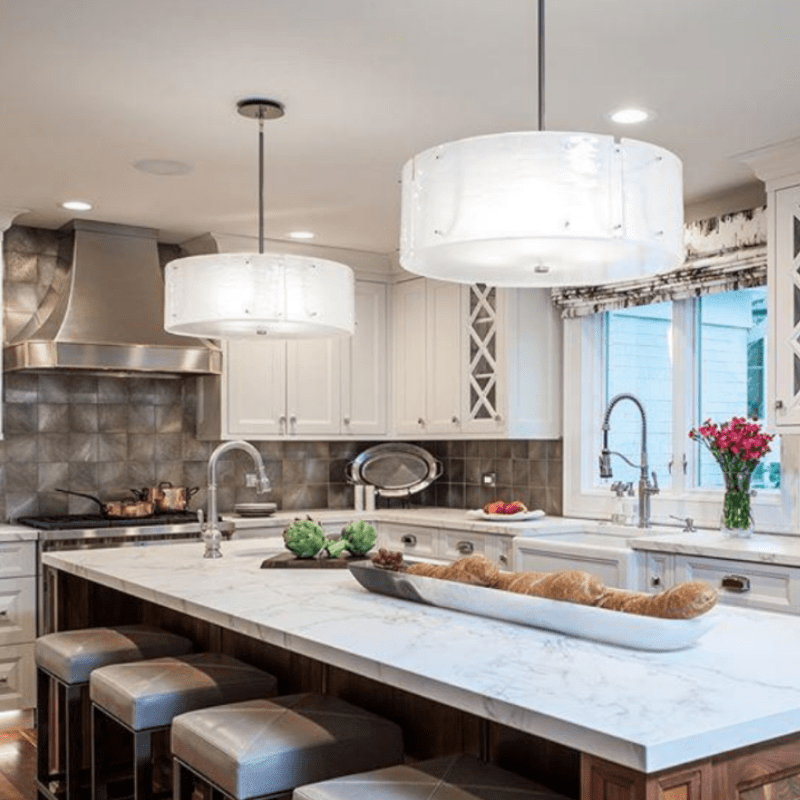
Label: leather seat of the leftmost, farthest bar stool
xmin=36 ymin=625 xmax=192 ymax=684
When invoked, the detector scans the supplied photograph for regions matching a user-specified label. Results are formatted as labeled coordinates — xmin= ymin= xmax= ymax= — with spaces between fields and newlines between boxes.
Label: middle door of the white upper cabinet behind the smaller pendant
xmin=286 ymin=338 xmax=341 ymax=436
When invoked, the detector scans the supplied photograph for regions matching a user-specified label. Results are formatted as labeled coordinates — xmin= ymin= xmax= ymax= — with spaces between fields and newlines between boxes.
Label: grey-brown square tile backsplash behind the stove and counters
xmin=0 ymin=226 xmax=562 ymax=520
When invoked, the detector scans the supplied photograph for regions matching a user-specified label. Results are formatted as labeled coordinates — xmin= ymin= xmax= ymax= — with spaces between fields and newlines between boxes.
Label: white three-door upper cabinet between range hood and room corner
xmin=205 ymin=281 xmax=387 ymax=440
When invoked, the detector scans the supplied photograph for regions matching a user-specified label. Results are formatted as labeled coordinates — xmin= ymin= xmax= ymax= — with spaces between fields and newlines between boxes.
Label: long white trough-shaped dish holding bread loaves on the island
xmin=348 ymin=561 xmax=717 ymax=651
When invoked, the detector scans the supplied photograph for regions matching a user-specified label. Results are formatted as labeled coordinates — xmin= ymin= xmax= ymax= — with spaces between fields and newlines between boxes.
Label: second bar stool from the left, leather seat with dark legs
xmin=89 ymin=653 xmax=278 ymax=800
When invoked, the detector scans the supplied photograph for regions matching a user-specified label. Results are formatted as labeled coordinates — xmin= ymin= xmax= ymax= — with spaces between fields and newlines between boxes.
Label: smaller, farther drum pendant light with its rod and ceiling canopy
xmin=164 ymin=99 xmax=355 ymax=339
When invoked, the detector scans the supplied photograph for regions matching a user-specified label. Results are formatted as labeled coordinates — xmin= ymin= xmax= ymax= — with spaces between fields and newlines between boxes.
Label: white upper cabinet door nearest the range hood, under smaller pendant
xmin=223 ymin=339 xmax=287 ymax=438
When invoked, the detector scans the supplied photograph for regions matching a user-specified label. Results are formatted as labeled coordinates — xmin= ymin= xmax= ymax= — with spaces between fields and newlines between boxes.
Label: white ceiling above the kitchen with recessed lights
xmin=0 ymin=0 xmax=800 ymax=253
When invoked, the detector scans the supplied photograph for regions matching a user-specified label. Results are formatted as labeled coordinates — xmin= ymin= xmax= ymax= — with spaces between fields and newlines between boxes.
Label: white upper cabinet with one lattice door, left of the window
xmin=392 ymin=278 xmax=562 ymax=439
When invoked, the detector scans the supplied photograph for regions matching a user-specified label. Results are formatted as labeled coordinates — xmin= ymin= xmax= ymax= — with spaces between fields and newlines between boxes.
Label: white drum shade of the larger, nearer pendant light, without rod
xmin=400 ymin=131 xmax=684 ymax=287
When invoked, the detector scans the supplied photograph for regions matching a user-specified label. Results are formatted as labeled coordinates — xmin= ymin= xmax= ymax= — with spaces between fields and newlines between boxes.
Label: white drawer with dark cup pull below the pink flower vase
xmin=675 ymin=556 xmax=800 ymax=612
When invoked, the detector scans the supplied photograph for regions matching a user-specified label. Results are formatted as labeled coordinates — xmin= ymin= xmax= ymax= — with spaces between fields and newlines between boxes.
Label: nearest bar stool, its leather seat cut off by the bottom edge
xmin=292 ymin=755 xmax=566 ymax=800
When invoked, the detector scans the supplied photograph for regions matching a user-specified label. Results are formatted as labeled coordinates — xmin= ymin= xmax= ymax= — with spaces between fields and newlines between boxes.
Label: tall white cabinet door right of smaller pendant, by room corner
xmin=341 ymin=281 xmax=388 ymax=436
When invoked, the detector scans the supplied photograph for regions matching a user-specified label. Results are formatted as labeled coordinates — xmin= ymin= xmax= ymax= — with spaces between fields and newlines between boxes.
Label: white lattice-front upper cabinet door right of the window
xmin=767 ymin=186 xmax=800 ymax=432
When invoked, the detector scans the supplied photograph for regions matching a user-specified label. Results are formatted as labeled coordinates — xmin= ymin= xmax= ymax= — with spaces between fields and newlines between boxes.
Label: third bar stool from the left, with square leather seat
xmin=171 ymin=693 xmax=403 ymax=800
